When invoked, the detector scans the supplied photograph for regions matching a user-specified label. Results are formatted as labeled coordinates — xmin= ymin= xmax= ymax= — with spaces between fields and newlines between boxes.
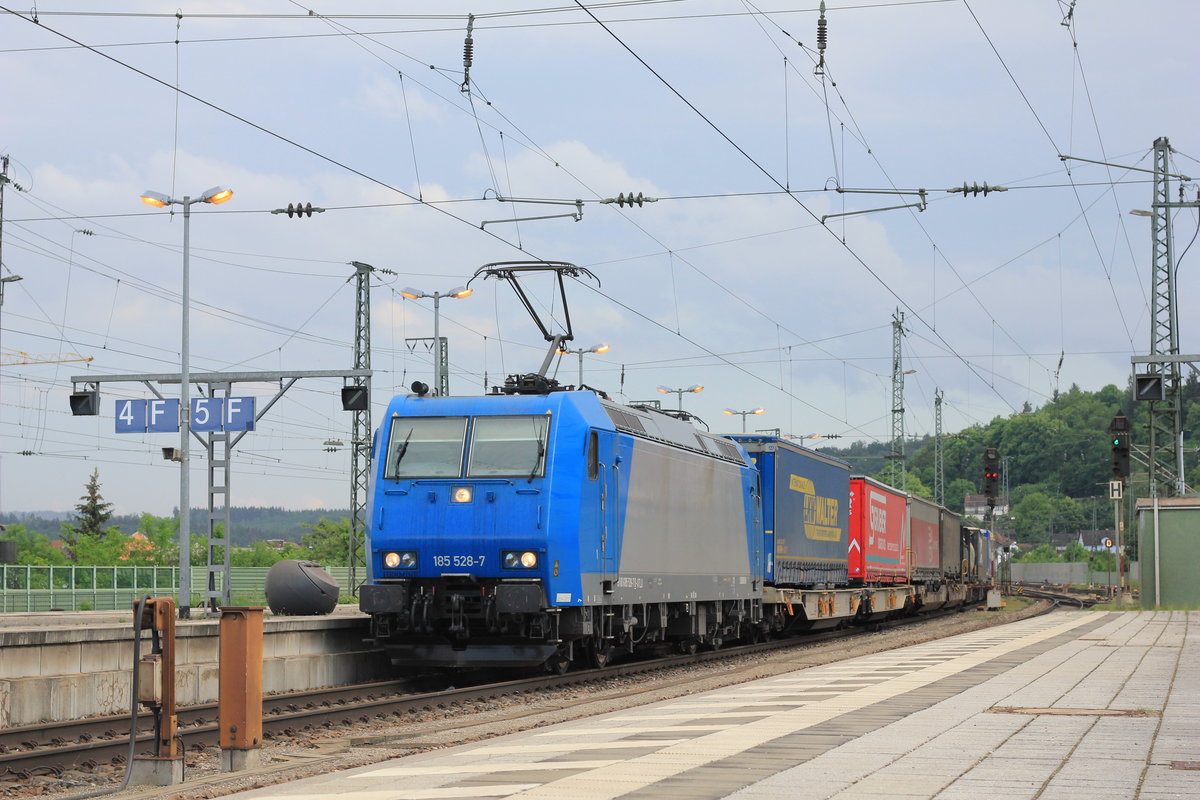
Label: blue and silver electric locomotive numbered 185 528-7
xmin=360 ymin=391 xmax=764 ymax=670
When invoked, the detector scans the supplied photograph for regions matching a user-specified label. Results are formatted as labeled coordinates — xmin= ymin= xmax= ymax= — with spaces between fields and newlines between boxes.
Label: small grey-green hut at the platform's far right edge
xmin=1138 ymin=498 xmax=1200 ymax=608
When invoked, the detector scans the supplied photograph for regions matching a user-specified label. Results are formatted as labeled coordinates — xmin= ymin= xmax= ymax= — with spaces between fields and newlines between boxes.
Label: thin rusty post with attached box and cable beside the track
xmin=130 ymin=597 xmax=184 ymax=786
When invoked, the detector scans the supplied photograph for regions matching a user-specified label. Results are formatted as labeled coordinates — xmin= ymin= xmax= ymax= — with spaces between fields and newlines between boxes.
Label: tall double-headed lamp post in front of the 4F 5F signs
xmin=142 ymin=186 xmax=233 ymax=619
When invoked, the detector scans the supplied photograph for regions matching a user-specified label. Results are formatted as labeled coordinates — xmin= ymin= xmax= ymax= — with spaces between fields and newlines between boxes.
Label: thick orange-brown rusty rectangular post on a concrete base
xmin=217 ymin=606 xmax=263 ymax=772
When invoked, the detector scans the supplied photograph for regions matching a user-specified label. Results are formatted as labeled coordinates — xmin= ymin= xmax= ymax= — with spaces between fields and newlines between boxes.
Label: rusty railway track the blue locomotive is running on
xmin=0 ymin=604 xmax=1052 ymax=788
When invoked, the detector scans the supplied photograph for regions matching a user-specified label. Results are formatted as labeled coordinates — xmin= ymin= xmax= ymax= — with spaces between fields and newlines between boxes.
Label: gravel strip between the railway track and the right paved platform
xmin=0 ymin=601 xmax=1048 ymax=800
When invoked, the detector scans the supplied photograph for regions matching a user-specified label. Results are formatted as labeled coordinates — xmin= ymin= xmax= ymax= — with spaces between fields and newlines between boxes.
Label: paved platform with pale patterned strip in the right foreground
xmin=218 ymin=612 xmax=1200 ymax=800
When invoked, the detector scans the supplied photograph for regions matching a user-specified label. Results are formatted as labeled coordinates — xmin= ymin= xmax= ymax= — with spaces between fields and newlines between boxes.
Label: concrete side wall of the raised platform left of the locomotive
xmin=0 ymin=607 xmax=391 ymax=728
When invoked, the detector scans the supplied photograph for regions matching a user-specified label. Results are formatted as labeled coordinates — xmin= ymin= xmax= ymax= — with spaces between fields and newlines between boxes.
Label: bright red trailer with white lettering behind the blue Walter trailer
xmin=848 ymin=475 xmax=908 ymax=584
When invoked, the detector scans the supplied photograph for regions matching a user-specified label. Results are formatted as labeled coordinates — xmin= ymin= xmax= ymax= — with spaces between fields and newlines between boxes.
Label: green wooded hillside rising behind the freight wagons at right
xmin=820 ymin=374 xmax=1200 ymax=545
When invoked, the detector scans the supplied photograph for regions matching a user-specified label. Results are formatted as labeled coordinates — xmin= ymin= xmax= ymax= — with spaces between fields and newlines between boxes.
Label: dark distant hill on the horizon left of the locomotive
xmin=0 ymin=506 xmax=350 ymax=547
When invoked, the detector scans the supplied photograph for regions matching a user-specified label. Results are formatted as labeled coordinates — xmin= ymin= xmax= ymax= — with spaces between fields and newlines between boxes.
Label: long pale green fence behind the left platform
xmin=0 ymin=564 xmax=349 ymax=613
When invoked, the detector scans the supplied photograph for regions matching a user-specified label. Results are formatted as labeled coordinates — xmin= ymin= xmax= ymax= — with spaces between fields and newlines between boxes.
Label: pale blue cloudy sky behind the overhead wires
xmin=0 ymin=0 xmax=1200 ymax=516
